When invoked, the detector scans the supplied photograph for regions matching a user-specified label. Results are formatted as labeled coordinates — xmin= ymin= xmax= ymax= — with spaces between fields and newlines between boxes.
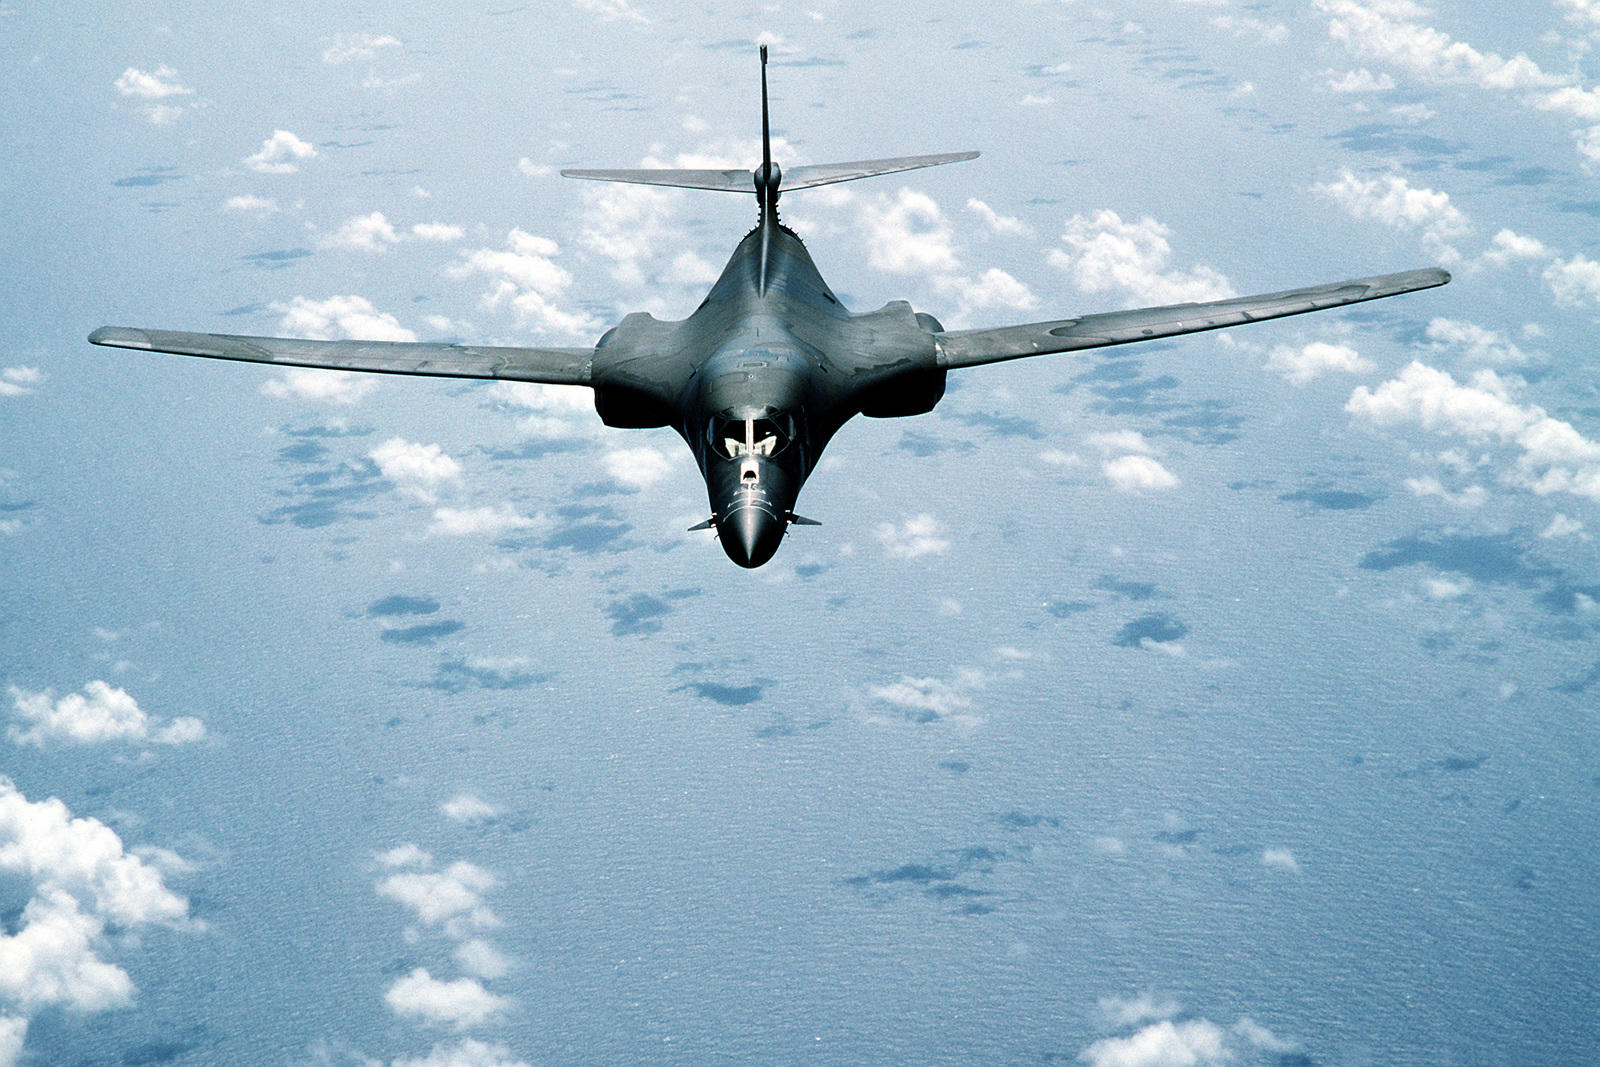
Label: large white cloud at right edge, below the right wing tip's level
xmin=1346 ymin=362 xmax=1600 ymax=501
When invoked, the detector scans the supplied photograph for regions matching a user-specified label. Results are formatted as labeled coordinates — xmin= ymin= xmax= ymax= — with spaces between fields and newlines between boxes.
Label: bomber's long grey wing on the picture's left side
xmin=90 ymin=326 xmax=594 ymax=386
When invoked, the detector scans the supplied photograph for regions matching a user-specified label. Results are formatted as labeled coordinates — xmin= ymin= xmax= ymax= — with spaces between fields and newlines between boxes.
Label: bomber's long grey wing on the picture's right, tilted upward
xmin=934 ymin=267 xmax=1450 ymax=366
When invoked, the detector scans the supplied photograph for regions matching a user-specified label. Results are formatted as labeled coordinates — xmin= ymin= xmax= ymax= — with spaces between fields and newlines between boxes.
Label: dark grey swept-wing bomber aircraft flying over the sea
xmin=90 ymin=46 xmax=1450 ymax=568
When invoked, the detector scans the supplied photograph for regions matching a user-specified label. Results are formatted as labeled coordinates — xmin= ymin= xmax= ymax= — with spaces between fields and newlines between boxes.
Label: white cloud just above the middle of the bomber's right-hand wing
xmin=1048 ymin=211 xmax=1237 ymax=306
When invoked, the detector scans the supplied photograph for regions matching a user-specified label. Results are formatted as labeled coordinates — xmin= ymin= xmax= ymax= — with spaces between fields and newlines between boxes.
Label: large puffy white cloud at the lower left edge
xmin=0 ymin=776 xmax=190 ymax=1062
